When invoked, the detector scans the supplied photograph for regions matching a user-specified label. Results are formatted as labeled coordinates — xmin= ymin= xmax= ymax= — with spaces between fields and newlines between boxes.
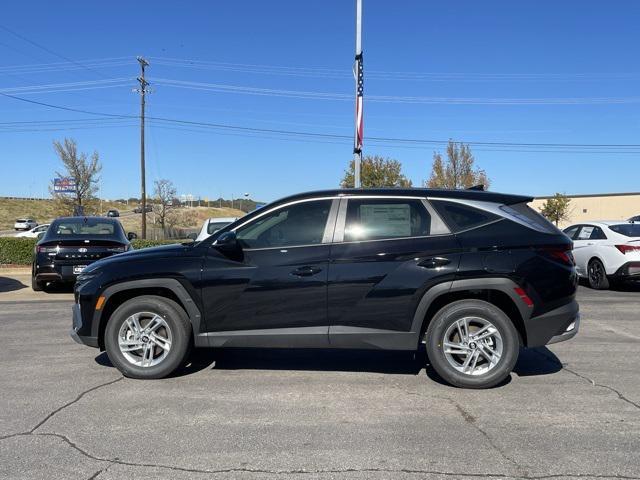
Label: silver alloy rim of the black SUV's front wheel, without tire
xmin=118 ymin=312 xmax=173 ymax=368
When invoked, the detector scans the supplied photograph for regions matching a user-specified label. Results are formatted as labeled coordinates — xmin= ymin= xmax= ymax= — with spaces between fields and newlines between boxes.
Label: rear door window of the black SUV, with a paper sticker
xmin=344 ymin=198 xmax=431 ymax=242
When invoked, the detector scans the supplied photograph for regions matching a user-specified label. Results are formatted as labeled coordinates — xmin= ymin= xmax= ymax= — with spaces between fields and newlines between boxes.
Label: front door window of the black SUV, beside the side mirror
xmin=236 ymin=200 xmax=332 ymax=248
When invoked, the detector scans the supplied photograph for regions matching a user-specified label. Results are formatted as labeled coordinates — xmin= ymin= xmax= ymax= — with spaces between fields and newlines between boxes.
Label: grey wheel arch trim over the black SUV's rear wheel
xmin=411 ymin=277 xmax=531 ymax=345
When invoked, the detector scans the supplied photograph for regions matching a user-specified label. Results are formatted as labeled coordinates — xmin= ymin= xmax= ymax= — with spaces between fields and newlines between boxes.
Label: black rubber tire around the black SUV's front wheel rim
xmin=104 ymin=295 xmax=191 ymax=380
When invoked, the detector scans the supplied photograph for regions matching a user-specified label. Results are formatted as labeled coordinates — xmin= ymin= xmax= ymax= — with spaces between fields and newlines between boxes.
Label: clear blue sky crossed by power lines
xmin=0 ymin=0 xmax=640 ymax=201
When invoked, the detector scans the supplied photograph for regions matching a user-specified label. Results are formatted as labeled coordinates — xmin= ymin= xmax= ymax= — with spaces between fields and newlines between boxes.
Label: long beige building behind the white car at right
xmin=531 ymin=192 xmax=640 ymax=227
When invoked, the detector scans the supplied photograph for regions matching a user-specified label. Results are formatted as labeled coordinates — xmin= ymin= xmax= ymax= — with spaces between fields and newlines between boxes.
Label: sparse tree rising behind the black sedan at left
xmin=49 ymin=138 xmax=102 ymax=215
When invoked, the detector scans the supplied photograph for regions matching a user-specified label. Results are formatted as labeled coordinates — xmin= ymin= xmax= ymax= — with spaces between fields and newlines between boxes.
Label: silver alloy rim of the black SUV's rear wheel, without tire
xmin=442 ymin=317 xmax=503 ymax=376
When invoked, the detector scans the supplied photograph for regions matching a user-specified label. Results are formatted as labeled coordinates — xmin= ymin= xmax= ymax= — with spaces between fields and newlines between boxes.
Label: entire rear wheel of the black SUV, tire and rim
xmin=426 ymin=300 xmax=520 ymax=388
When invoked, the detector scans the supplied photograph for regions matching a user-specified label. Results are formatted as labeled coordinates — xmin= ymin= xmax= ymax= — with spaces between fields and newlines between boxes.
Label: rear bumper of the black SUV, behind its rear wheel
xmin=525 ymin=300 xmax=580 ymax=347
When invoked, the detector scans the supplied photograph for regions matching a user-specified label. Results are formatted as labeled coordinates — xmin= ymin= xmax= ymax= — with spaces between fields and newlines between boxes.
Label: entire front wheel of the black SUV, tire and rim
xmin=104 ymin=295 xmax=191 ymax=379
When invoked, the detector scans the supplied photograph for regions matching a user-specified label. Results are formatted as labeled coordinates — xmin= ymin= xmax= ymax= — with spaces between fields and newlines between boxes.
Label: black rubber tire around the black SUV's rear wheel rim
xmin=425 ymin=300 xmax=520 ymax=388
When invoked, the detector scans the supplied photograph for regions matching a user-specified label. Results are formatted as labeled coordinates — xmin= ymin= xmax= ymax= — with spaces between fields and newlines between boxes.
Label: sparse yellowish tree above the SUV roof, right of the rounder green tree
xmin=425 ymin=140 xmax=491 ymax=189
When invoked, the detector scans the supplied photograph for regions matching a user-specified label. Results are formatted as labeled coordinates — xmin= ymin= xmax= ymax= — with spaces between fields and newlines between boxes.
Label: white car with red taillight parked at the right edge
xmin=564 ymin=220 xmax=640 ymax=290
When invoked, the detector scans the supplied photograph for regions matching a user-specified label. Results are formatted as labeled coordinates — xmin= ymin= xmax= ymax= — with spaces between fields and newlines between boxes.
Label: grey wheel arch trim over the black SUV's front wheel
xmin=91 ymin=278 xmax=206 ymax=350
